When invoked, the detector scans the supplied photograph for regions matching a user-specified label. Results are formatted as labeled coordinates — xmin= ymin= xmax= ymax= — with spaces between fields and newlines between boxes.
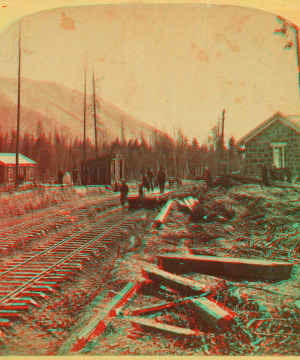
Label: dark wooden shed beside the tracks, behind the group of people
xmin=81 ymin=154 xmax=125 ymax=185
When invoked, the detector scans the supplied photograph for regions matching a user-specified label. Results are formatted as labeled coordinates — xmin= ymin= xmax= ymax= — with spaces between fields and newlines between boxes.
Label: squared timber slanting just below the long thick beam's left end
xmin=142 ymin=267 xmax=207 ymax=295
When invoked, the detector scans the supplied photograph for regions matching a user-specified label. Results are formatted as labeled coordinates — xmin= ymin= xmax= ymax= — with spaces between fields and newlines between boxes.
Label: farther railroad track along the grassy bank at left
xmin=0 ymin=196 xmax=120 ymax=256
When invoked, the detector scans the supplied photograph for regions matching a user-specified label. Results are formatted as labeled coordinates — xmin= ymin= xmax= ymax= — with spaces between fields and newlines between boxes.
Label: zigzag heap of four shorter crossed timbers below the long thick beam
xmin=130 ymin=266 xmax=236 ymax=337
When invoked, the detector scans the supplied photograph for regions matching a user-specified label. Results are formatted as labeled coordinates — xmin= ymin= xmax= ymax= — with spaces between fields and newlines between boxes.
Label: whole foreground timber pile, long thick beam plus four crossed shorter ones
xmin=130 ymin=250 xmax=293 ymax=337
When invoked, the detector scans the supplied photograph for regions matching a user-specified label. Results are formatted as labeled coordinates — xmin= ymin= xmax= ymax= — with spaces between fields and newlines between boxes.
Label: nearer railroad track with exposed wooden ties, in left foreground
xmin=0 ymin=207 xmax=145 ymax=329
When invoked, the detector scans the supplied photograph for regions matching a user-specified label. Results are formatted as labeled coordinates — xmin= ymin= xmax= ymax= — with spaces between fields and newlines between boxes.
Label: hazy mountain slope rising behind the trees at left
xmin=0 ymin=77 xmax=157 ymax=142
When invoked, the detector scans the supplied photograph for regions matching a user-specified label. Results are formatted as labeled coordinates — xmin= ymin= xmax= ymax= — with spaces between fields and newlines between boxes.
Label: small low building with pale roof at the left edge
xmin=0 ymin=153 xmax=38 ymax=184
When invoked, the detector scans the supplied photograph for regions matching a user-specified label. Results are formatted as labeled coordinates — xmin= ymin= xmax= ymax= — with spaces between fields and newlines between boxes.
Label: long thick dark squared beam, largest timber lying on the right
xmin=157 ymin=255 xmax=294 ymax=280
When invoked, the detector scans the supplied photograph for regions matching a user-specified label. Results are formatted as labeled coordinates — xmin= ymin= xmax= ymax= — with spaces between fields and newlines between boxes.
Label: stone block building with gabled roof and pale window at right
xmin=238 ymin=112 xmax=300 ymax=178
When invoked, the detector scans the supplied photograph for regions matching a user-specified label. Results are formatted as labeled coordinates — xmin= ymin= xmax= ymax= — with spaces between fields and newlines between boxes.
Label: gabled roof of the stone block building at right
xmin=237 ymin=111 xmax=300 ymax=145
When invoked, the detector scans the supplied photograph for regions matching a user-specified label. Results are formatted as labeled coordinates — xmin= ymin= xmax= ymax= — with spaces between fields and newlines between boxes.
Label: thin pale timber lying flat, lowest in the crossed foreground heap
xmin=130 ymin=318 xmax=203 ymax=337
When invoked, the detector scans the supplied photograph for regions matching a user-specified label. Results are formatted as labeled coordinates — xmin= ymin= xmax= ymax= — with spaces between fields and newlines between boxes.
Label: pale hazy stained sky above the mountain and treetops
xmin=0 ymin=5 xmax=300 ymax=141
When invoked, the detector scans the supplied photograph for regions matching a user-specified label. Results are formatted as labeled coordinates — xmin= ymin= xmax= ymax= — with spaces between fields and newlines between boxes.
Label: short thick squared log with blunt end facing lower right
xmin=190 ymin=298 xmax=236 ymax=330
